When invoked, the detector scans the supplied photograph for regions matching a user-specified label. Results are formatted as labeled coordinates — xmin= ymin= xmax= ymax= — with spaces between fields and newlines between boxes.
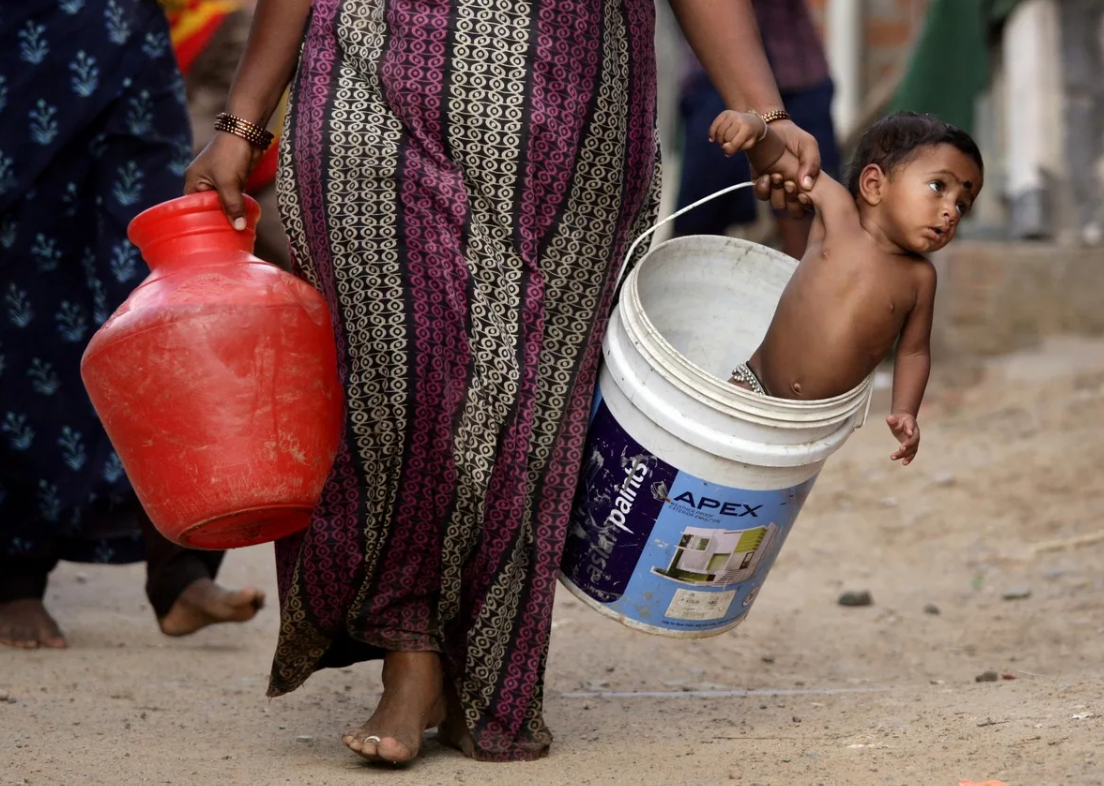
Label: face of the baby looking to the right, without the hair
xmin=884 ymin=145 xmax=981 ymax=254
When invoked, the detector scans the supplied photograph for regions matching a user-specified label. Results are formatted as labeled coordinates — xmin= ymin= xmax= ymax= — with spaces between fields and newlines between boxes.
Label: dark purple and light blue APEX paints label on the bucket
xmin=561 ymin=394 xmax=816 ymax=631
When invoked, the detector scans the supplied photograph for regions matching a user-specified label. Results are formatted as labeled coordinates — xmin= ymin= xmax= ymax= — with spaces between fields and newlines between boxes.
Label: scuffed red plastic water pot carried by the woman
xmin=81 ymin=191 xmax=342 ymax=549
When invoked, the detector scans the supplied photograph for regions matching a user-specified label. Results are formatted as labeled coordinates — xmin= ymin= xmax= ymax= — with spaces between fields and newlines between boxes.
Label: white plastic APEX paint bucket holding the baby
xmin=561 ymin=184 xmax=872 ymax=638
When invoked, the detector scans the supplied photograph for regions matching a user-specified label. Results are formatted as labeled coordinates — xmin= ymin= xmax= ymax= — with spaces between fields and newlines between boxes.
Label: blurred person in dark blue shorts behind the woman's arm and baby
xmin=673 ymin=0 xmax=840 ymax=259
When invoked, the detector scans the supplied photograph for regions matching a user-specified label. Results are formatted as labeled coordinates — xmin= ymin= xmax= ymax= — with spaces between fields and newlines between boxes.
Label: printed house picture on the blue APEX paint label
xmin=651 ymin=522 xmax=778 ymax=587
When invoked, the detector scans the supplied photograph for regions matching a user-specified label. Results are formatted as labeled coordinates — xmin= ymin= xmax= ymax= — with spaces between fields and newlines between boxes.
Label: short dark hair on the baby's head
xmin=847 ymin=111 xmax=985 ymax=198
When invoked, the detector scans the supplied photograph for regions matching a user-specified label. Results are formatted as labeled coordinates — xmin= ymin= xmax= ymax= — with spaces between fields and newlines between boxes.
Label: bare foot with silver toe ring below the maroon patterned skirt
xmin=341 ymin=652 xmax=446 ymax=764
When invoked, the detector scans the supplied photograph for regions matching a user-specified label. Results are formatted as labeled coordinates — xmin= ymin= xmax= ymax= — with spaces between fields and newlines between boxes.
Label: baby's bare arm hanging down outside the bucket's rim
xmin=885 ymin=262 xmax=935 ymax=466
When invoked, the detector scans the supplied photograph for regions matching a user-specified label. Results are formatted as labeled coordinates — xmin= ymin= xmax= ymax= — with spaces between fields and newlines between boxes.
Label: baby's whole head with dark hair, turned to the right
xmin=848 ymin=111 xmax=985 ymax=254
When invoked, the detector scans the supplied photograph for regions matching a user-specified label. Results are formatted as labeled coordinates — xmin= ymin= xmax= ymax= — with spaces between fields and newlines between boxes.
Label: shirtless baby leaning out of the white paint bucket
xmin=710 ymin=111 xmax=984 ymax=465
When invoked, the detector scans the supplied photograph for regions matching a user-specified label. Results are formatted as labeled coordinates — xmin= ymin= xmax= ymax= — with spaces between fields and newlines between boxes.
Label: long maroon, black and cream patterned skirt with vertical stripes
xmin=269 ymin=0 xmax=659 ymax=761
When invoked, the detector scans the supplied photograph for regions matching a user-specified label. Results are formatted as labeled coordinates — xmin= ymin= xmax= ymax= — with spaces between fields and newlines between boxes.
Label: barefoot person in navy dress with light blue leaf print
xmin=0 ymin=0 xmax=264 ymax=648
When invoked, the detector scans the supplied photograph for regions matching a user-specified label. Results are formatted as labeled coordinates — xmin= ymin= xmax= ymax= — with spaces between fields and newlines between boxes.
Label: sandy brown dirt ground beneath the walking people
xmin=0 ymin=340 xmax=1104 ymax=786
